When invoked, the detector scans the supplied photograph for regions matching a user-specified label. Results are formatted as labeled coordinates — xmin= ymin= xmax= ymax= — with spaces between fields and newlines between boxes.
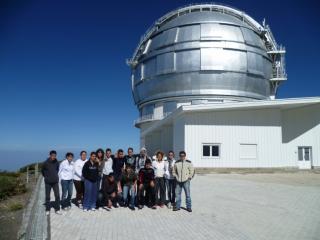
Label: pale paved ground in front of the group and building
xmin=50 ymin=173 xmax=320 ymax=240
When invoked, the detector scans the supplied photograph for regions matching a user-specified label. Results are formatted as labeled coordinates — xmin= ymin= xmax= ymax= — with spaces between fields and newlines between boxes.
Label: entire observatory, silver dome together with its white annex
xmin=127 ymin=4 xmax=320 ymax=169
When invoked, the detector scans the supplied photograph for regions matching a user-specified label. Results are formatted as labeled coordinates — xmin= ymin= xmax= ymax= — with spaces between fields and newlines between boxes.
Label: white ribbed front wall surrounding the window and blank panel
xmin=184 ymin=109 xmax=284 ymax=168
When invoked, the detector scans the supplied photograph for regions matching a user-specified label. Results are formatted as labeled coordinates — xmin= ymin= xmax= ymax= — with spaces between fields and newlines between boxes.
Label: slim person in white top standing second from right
xmin=165 ymin=151 xmax=176 ymax=208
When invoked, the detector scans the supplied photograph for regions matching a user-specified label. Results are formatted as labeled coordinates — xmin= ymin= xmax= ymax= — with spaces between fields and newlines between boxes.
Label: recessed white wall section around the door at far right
xmin=282 ymin=104 xmax=320 ymax=167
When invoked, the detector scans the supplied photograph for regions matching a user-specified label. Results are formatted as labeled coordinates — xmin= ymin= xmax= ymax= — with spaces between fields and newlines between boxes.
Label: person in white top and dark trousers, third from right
xmin=152 ymin=151 xmax=166 ymax=208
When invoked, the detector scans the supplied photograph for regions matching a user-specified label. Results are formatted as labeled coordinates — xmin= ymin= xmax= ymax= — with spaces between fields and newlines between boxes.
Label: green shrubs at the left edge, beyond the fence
xmin=0 ymin=172 xmax=27 ymax=201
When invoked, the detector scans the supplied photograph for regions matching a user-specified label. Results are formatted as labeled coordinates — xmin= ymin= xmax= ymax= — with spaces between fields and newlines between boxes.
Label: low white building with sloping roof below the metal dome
xmin=141 ymin=98 xmax=320 ymax=169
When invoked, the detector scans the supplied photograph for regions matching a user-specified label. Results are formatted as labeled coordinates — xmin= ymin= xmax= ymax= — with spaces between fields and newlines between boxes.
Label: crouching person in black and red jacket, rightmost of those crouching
xmin=138 ymin=159 xmax=157 ymax=209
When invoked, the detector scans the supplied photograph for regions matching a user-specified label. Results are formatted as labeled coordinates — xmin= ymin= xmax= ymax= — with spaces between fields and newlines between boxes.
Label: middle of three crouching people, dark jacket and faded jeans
xmin=121 ymin=164 xmax=137 ymax=210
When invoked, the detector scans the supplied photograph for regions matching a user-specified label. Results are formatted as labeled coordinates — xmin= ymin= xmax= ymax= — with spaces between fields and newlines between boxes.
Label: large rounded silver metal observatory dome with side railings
xmin=128 ymin=4 xmax=286 ymax=125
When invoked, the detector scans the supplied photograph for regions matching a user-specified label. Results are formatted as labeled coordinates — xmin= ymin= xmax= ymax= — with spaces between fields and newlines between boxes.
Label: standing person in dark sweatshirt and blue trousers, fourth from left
xmin=82 ymin=152 xmax=99 ymax=211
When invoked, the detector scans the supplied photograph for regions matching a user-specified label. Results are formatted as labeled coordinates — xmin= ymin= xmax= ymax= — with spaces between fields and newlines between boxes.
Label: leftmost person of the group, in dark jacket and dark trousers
xmin=41 ymin=150 xmax=61 ymax=215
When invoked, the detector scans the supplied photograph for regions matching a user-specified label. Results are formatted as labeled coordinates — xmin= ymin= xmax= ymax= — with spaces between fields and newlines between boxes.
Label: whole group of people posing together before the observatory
xmin=42 ymin=147 xmax=195 ymax=215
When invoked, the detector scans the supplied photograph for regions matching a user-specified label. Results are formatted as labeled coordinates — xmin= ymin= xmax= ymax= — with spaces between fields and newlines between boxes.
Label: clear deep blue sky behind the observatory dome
xmin=0 ymin=0 xmax=320 ymax=170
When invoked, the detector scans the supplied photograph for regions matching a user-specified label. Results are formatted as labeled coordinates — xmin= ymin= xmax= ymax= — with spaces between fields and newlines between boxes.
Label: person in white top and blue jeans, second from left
xmin=59 ymin=152 xmax=74 ymax=210
